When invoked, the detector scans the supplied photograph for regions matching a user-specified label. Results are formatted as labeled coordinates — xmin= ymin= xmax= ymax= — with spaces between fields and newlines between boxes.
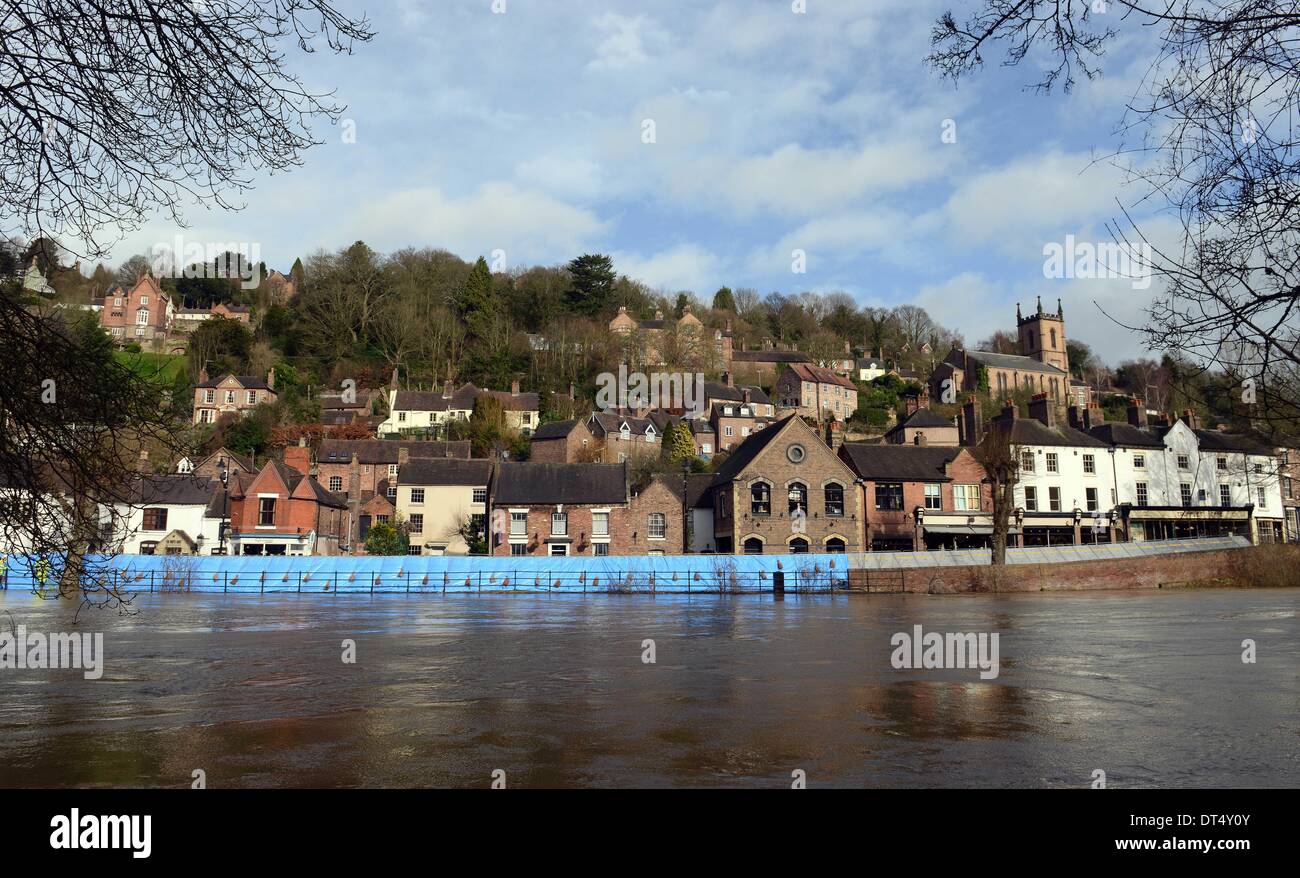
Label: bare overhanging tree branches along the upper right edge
xmin=930 ymin=0 xmax=1300 ymax=445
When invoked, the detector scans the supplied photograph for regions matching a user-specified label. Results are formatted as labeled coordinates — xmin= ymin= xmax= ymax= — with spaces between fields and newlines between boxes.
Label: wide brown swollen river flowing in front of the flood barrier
xmin=0 ymin=589 xmax=1300 ymax=788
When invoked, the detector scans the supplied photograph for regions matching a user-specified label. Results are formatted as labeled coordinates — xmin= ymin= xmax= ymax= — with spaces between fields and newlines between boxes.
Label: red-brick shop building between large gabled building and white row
xmin=840 ymin=447 xmax=987 ymax=552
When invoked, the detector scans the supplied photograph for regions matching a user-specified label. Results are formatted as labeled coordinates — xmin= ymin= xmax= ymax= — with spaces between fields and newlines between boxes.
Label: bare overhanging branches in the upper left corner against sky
xmin=0 ymin=0 xmax=372 ymax=255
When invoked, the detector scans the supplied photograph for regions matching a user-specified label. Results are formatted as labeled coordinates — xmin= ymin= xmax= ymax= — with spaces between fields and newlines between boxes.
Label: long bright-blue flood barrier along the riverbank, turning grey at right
xmin=0 ymin=537 xmax=1249 ymax=594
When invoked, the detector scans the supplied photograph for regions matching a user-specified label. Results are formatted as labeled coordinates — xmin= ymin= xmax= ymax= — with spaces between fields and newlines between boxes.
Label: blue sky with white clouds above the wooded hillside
xmin=101 ymin=0 xmax=1171 ymax=364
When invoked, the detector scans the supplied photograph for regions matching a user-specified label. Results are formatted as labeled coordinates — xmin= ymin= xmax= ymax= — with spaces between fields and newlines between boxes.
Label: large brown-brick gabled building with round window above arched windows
xmin=710 ymin=415 xmax=862 ymax=554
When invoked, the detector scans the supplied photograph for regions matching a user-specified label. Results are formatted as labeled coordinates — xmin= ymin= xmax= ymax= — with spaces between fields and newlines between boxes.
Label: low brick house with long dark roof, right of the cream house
xmin=489 ymin=463 xmax=636 ymax=557
